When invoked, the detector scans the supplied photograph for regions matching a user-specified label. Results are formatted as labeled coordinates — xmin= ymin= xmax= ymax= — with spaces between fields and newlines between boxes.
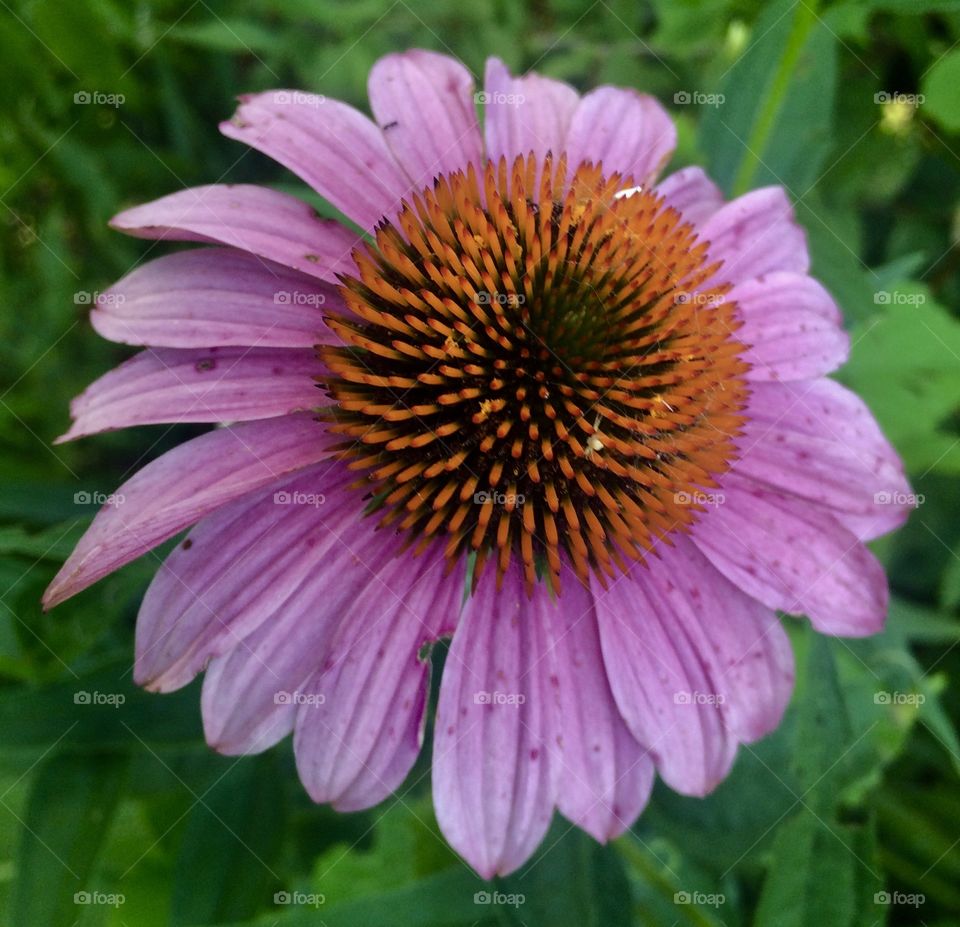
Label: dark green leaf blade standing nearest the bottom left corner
xmin=12 ymin=754 xmax=126 ymax=927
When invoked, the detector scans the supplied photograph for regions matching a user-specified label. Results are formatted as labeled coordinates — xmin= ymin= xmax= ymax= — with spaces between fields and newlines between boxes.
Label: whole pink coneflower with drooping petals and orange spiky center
xmin=46 ymin=51 xmax=909 ymax=877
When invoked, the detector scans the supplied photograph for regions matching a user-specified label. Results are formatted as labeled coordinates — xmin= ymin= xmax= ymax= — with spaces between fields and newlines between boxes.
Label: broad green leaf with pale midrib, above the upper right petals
xmin=700 ymin=0 xmax=837 ymax=196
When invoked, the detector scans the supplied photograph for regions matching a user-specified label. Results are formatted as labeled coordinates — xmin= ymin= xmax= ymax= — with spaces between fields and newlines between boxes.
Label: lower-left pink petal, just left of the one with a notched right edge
xmin=201 ymin=520 xmax=404 ymax=754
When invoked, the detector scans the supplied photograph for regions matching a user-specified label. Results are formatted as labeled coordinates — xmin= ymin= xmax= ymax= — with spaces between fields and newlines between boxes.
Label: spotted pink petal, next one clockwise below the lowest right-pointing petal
xmin=640 ymin=535 xmax=794 ymax=743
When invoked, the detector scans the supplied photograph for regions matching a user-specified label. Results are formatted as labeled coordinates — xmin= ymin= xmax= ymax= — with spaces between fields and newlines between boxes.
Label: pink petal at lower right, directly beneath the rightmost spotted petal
xmin=693 ymin=472 xmax=888 ymax=637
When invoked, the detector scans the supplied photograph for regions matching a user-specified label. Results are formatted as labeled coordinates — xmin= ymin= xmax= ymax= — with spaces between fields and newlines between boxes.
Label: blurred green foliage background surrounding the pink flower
xmin=0 ymin=0 xmax=960 ymax=927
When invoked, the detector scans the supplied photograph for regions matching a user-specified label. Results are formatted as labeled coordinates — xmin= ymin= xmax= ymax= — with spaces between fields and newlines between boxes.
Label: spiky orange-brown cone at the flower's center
xmin=320 ymin=154 xmax=748 ymax=592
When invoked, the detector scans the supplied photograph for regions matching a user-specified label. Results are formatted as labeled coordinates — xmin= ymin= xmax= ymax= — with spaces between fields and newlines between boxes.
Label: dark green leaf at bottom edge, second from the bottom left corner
xmin=170 ymin=753 xmax=284 ymax=927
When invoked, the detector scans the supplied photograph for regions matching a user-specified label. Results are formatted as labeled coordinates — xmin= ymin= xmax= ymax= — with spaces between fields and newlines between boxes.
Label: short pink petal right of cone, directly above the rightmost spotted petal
xmin=736 ymin=271 xmax=850 ymax=380
